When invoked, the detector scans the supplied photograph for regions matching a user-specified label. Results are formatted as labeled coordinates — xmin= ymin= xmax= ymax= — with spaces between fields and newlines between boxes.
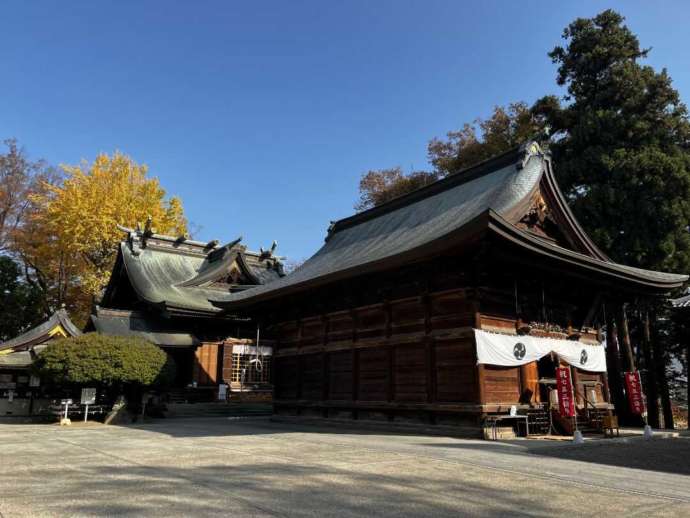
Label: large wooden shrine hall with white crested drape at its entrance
xmin=209 ymin=143 xmax=687 ymax=434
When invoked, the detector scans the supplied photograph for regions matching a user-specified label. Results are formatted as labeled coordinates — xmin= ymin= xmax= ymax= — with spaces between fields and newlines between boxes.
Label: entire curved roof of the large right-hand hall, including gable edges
xmin=211 ymin=143 xmax=687 ymax=307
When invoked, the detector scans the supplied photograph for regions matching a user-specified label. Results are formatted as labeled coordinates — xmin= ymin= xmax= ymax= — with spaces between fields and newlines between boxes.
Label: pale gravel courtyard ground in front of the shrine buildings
xmin=0 ymin=418 xmax=690 ymax=518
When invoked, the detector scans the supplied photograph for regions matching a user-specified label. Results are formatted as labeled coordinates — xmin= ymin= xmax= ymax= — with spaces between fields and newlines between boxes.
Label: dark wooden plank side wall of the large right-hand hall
xmin=273 ymin=289 xmax=478 ymax=422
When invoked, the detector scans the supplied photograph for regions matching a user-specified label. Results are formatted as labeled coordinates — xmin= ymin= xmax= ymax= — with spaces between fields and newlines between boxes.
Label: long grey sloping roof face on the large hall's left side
xmin=212 ymin=142 xmax=543 ymax=305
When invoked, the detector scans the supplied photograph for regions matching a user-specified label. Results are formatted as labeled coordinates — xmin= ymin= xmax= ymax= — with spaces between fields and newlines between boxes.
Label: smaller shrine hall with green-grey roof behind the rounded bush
xmin=87 ymin=222 xmax=284 ymax=400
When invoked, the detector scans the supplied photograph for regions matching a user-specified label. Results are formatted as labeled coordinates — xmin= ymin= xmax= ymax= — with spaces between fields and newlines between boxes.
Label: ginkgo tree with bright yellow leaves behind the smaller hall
xmin=17 ymin=152 xmax=187 ymax=317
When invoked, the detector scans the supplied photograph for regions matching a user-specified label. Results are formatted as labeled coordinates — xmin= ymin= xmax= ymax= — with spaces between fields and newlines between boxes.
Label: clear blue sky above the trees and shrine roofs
xmin=0 ymin=0 xmax=690 ymax=260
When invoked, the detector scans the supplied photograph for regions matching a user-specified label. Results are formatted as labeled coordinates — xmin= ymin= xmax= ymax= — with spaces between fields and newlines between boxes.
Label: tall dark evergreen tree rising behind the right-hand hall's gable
xmin=533 ymin=10 xmax=690 ymax=272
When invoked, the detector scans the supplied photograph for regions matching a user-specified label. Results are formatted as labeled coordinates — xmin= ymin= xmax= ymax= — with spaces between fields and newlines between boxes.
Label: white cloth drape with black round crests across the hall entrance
xmin=474 ymin=329 xmax=606 ymax=372
